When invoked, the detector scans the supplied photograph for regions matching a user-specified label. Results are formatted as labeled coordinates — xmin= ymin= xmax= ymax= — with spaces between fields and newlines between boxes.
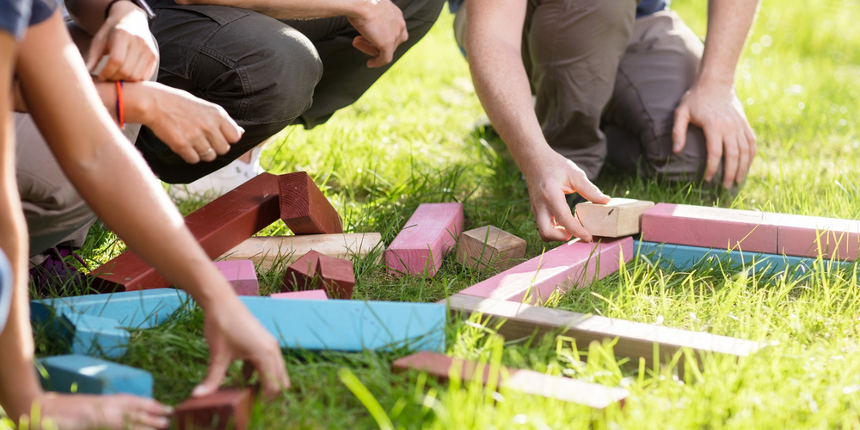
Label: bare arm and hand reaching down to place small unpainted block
xmin=465 ymin=0 xmax=609 ymax=241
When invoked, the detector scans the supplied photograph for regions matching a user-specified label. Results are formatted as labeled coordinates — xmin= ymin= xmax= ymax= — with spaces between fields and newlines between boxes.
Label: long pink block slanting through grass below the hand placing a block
xmin=460 ymin=237 xmax=633 ymax=303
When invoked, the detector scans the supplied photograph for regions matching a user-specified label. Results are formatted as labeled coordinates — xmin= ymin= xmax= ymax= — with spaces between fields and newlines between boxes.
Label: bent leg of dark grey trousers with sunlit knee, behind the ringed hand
xmin=142 ymin=4 xmax=322 ymax=183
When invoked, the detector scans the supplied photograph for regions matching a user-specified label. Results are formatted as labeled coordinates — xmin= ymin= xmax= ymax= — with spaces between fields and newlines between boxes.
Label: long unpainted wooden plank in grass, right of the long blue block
xmin=447 ymin=294 xmax=765 ymax=369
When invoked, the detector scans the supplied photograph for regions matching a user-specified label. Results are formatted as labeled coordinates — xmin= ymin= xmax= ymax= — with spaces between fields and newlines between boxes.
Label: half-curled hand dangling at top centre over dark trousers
xmin=349 ymin=0 xmax=409 ymax=67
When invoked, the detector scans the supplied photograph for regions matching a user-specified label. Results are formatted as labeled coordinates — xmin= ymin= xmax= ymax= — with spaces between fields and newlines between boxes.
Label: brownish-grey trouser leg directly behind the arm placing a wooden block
xmin=523 ymin=0 xmax=637 ymax=180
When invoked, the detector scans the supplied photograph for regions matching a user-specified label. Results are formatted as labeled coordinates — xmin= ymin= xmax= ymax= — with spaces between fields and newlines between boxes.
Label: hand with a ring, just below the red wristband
xmin=131 ymin=82 xmax=245 ymax=164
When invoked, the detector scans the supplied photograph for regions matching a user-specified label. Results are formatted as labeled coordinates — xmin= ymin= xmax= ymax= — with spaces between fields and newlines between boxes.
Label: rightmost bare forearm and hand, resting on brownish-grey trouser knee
xmin=673 ymin=0 xmax=758 ymax=188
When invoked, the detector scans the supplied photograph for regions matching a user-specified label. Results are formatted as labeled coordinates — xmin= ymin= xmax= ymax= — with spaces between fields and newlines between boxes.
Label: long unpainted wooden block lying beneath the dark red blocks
xmin=218 ymin=233 xmax=382 ymax=270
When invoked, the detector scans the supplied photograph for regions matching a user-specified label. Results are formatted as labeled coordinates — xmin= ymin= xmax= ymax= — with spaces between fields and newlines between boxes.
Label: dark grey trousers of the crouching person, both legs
xmin=136 ymin=0 xmax=444 ymax=183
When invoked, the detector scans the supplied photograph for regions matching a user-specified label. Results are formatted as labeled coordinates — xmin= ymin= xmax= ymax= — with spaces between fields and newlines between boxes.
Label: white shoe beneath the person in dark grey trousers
xmin=168 ymin=145 xmax=263 ymax=200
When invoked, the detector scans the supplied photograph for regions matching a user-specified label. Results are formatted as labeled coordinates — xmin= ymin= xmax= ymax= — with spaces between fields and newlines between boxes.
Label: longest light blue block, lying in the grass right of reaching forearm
xmin=239 ymin=297 xmax=446 ymax=352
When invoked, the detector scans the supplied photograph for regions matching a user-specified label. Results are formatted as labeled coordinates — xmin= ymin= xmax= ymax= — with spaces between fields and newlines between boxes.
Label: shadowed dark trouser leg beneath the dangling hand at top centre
xmin=286 ymin=0 xmax=445 ymax=128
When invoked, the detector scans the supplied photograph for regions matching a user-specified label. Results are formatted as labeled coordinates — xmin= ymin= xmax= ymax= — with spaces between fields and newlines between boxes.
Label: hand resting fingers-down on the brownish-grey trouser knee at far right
xmin=672 ymin=85 xmax=756 ymax=188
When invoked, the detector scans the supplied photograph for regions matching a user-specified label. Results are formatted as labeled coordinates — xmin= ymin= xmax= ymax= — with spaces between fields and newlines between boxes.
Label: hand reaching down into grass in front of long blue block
xmin=191 ymin=297 xmax=290 ymax=399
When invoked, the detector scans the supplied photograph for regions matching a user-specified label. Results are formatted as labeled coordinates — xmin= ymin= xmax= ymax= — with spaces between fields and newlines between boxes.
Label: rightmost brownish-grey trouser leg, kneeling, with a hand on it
xmin=603 ymin=11 xmax=722 ymax=181
